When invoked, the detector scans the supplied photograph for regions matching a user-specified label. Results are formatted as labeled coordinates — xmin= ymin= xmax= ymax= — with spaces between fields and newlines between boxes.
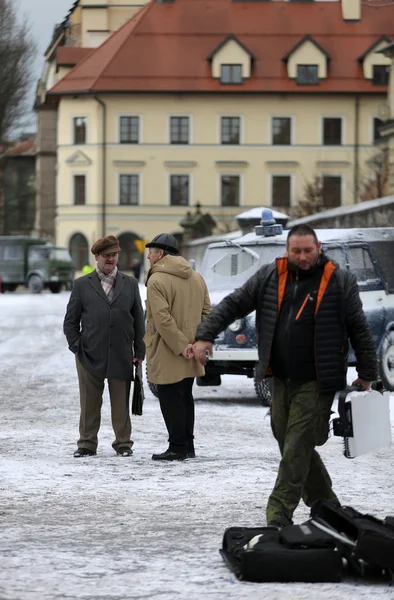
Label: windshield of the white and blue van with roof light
xmin=201 ymin=244 xmax=285 ymax=290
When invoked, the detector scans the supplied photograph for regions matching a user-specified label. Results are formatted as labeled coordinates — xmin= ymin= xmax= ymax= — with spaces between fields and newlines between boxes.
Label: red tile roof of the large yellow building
xmin=49 ymin=0 xmax=394 ymax=98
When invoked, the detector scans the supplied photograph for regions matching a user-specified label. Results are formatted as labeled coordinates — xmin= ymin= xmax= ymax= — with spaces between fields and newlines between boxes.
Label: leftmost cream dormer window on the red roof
xmin=207 ymin=34 xmax=254 ymax=85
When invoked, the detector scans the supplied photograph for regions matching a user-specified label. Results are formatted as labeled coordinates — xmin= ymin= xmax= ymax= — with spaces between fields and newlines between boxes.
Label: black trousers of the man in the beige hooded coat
xmin=157 ymin=377 xmax=194 ymax=454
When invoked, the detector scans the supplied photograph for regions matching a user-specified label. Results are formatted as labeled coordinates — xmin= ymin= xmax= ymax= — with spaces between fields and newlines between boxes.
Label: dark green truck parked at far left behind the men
xmin=0 ymin=236 xmax=75 ymax=294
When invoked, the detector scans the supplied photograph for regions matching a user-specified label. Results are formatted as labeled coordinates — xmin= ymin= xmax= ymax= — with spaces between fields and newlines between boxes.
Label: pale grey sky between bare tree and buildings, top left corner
xmin=17 ymin=0 xmax=74 ymax=131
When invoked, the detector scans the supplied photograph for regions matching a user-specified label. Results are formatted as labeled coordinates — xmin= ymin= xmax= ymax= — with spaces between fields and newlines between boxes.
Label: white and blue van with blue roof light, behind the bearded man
xmin=197 ymin=213 xmax=394 ymax=406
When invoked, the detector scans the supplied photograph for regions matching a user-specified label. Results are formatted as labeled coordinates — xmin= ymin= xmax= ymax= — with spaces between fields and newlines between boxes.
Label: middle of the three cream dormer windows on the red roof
xmin=282 ymin=35 xmax=330 ymax=85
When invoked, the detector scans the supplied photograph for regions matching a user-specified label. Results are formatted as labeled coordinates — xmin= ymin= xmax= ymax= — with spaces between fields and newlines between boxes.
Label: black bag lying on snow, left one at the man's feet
xmin=220 ymin=523 xmax=343 ymax=582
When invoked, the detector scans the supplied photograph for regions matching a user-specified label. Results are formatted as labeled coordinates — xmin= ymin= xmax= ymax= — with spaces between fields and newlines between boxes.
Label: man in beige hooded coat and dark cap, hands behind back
xmin=144 ymin=233 xmax=211 ymax=461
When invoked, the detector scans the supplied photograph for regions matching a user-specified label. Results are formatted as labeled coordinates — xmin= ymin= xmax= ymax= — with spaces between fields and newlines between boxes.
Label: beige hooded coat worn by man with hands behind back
xmin=144 ymin=255 xmax=211 ymax=384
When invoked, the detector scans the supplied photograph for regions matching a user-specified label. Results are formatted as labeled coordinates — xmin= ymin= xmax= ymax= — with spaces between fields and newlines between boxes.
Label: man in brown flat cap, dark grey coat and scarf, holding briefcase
xmin=63 ymin=235 xmax=145 ymax=458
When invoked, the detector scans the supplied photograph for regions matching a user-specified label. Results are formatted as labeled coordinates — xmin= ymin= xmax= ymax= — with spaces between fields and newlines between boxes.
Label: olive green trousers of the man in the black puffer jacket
xmin=267 ymin=377 xmax=339 ymax=525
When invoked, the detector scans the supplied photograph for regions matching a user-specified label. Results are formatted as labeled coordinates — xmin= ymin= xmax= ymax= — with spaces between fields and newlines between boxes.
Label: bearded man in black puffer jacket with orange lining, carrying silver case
xmin=194 ymin=225 xmax=377 ymax=527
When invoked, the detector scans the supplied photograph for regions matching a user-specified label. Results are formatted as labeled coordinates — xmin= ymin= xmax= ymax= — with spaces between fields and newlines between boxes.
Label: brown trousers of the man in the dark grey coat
xmin=75 ymin=356 xmax=133 ymax=450
